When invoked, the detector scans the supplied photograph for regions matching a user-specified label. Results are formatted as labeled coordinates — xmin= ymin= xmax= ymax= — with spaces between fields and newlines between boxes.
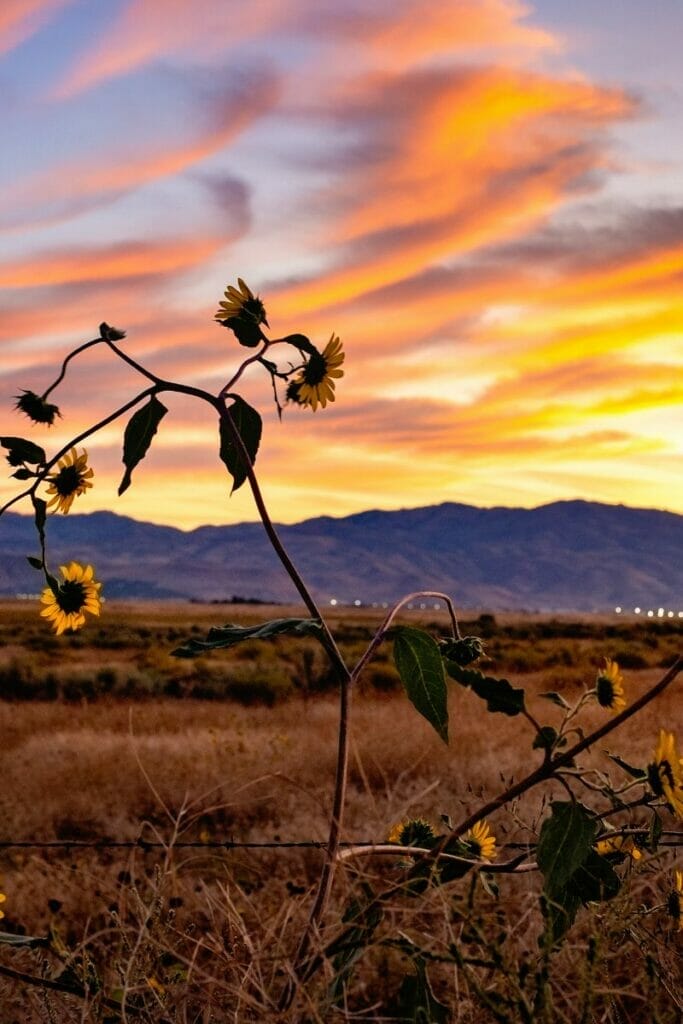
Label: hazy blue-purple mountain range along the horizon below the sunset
xmin=0 ymin=501 xmax=683 ymax=611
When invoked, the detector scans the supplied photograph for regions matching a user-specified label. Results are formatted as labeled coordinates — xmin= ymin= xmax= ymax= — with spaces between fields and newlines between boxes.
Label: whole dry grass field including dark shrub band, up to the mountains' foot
xmin=0 ymin=603 xmax=683 ymax=1024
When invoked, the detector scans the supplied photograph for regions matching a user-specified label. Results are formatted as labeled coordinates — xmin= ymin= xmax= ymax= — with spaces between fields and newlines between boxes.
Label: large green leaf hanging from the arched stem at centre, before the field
xmin=391 ymin=626 xmax=449 ymax=743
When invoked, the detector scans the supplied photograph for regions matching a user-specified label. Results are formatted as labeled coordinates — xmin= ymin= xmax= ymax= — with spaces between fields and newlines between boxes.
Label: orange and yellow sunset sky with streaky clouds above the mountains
xmin=0 ymin=0 xmax=683 ymax=527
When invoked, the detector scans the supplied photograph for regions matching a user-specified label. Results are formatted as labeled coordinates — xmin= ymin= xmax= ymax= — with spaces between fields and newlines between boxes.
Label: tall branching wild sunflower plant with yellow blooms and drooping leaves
xmin=0 ymin=279 xmax=683 ymax=1022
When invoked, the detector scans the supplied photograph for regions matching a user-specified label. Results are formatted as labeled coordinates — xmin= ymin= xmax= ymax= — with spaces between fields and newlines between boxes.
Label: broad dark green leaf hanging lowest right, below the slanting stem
xmin=536 ymin=801 xmax=597 ymax=897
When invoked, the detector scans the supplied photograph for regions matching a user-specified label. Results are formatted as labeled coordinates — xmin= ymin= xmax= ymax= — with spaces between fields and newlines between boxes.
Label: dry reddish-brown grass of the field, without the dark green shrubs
xmin=0 ymin=606 xmax=680 ymax=1024
